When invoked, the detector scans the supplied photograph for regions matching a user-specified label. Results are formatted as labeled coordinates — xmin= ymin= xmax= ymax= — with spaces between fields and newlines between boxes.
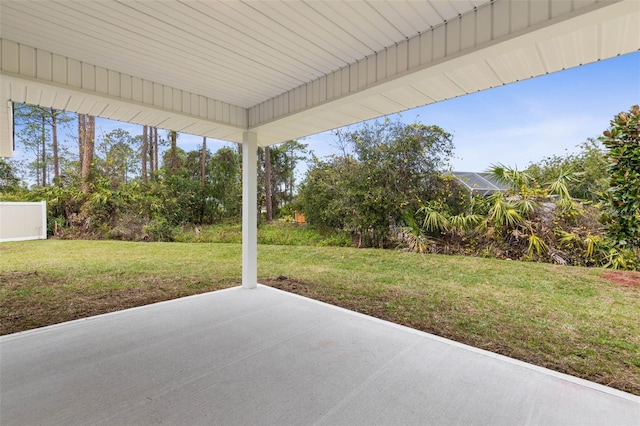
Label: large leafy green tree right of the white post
xmin=298 ymin=120 xmax=453 ymax=247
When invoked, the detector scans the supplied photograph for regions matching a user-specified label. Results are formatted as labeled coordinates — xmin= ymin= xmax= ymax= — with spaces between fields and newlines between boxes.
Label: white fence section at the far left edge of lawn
xmin=0 ymin=201 xmax=47 ymax=242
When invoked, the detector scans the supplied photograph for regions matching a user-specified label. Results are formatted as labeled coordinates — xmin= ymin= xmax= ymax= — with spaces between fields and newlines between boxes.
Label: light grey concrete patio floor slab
xmin=0 ymin=286 xmax=640 ymax=426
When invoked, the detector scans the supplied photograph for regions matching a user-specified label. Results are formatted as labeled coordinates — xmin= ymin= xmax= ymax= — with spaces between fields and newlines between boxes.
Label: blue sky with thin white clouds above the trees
xmin=11 ymin=52 xmax=640 ymax=176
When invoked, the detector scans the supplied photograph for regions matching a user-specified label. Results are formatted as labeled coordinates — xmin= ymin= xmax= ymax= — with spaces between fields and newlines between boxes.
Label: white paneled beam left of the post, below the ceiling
xmin=0 ymin=39 xmax=247 ymax=142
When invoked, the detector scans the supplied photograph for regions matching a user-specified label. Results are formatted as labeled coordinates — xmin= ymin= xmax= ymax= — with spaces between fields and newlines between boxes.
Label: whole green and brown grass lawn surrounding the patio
xmin=0 ymin=240 xmax=640 ymax=395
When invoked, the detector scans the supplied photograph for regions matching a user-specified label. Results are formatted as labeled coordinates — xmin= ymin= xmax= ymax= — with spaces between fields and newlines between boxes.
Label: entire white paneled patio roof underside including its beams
xmin=0 ymin=0 xmax=640 ymax=155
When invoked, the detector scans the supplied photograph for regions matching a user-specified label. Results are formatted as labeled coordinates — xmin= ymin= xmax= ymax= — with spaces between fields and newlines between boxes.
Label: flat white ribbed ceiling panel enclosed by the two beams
xmin=0 ymin=0 xmax=487 ymax=108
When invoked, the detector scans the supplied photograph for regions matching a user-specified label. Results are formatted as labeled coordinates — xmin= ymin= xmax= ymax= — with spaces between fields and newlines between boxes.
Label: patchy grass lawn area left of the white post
xmin=0 ymin=241 xmax=240 ymax=334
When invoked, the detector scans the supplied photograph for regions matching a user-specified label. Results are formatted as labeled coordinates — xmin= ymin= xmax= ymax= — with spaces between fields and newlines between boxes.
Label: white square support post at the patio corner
xmin=242 ymin=132 xmax=258 ymax=288
